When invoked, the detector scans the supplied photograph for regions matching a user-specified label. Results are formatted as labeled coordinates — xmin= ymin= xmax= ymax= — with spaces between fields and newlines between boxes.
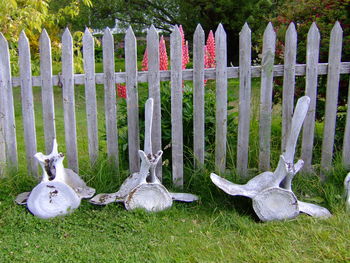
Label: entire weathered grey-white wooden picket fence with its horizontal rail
xmin=0 ymin=22 xmax=350 ymax=186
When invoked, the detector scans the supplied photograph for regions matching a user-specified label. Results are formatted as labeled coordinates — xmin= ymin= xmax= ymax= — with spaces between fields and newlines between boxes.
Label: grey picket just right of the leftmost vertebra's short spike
xmin=62 ymin=28 xmax=79 ymax=172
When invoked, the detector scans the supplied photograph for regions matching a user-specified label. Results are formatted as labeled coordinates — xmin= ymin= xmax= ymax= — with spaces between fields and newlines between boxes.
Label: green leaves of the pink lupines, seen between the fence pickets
xmin=118 ymin=82 xmax=237 ymax=173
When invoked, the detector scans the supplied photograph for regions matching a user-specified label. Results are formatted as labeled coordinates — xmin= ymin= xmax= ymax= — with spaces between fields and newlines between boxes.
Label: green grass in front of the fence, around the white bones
xmin=0 ymin=168 xmax=350 ymax=262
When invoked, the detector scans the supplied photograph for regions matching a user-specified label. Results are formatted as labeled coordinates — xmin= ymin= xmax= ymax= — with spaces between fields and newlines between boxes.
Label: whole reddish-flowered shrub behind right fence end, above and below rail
xmin=272 ymin=0 xmax=350 ymax=145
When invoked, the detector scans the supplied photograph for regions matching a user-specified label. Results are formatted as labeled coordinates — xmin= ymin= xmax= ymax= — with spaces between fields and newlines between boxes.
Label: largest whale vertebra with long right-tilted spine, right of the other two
xmin=210 ymin=96 xmax=331 ymax=221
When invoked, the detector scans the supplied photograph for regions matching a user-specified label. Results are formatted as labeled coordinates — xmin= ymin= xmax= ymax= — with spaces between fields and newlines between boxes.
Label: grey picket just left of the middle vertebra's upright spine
xmin=125 ymin=27 xmax=140 ymax=173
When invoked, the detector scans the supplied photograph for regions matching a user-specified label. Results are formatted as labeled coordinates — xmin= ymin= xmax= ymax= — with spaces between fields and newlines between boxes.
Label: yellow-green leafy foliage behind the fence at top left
xmin=0 ymin=0 xmax=91 ymax=75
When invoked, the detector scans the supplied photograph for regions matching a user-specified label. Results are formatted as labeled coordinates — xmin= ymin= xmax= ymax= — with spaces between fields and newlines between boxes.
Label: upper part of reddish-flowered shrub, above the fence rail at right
xmin=272 ymin=0 xmax=350 ymax=63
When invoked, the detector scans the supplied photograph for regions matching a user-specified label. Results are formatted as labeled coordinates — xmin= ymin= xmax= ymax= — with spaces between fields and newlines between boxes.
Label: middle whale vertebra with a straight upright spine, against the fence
xmin=89 ymin=98 xmax=198 ymax=212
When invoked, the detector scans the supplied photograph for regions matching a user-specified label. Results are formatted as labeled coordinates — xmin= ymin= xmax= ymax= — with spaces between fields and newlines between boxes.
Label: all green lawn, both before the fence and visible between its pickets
xmin=0 ymin=75 xmax=350 ymax=262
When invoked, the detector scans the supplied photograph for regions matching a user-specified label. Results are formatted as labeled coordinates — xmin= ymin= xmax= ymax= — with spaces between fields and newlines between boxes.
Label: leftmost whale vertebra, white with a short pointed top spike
xmin=15 ymin=140 xmax=95 ymax=218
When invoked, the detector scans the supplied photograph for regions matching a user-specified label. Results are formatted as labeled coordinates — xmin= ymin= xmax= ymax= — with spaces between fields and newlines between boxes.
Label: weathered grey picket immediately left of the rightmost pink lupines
xmin=193 ymin=24 xmax=205 ymax=167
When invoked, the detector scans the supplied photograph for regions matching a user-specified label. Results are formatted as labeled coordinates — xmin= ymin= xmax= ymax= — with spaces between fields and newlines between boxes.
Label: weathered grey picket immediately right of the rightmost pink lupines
xmin=215 ymin=24 xmax=227 ymax=173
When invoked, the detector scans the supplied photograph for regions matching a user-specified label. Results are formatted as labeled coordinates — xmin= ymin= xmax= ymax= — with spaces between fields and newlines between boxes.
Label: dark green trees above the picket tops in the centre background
xmin=67 ymin=0 xmax=278 ymax=64
